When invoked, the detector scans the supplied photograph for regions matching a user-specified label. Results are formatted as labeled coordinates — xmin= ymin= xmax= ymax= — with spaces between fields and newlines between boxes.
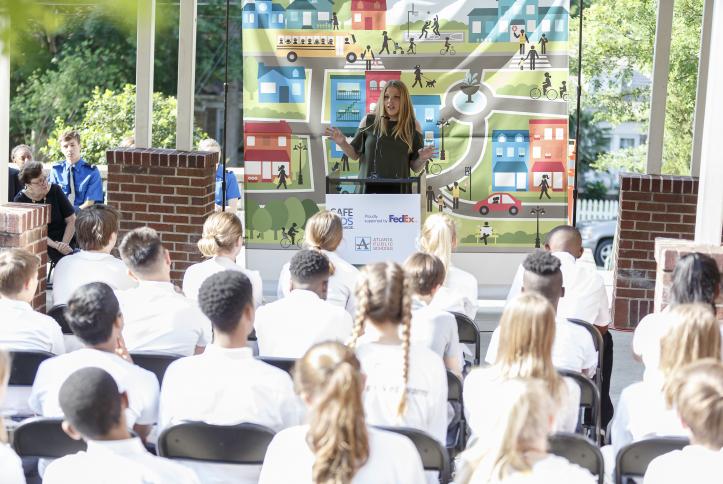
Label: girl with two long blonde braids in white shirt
xmin=350 ymin=262 xmax=447 ymax=445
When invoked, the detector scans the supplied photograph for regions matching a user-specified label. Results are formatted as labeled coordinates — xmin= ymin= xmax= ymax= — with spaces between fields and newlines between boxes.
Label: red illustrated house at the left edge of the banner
xmin=244 ymin=121 xmax=292 ymax=182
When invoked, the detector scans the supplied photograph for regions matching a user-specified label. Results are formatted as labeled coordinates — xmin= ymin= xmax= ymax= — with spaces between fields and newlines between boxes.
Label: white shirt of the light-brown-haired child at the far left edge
xmin=0 ymin=299 xmax=65 ymax=355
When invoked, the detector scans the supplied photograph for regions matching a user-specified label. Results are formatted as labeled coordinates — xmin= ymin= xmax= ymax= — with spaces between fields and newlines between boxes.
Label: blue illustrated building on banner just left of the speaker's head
xmin=331 ymin=74 xmax=366 ymax=157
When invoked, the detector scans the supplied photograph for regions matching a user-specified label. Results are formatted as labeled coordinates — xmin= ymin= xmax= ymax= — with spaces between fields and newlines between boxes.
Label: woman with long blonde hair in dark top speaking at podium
xmin=325 ymin=80 xmax=436 ymax=193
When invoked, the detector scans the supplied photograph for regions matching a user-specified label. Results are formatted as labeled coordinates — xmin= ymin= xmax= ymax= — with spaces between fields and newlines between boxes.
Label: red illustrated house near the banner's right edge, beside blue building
xmin=529 ymin=119 xmax=568 ymax=191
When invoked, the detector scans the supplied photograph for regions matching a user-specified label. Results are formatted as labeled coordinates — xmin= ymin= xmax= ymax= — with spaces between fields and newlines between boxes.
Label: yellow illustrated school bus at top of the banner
xmin=276 ymin=31 xmax=357 ymax=64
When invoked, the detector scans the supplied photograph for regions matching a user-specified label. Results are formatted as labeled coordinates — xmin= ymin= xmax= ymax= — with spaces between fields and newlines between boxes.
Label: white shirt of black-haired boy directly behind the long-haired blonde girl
xmin=485 ymin=316 xmax=598 ymax=376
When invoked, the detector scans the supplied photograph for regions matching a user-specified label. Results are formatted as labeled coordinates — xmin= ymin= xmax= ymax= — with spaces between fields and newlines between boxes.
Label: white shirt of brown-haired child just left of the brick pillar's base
xmin=53 ymin=250 xmax=138 ymax=306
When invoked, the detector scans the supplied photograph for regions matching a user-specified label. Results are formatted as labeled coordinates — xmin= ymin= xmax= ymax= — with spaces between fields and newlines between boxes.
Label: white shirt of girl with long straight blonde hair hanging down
xmin=462 ymin=366 xmax=580 ymax=435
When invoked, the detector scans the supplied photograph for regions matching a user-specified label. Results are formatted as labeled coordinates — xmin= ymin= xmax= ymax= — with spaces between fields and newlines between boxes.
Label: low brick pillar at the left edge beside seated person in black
xmin=0 ymin=203 xmax=50 ymax=312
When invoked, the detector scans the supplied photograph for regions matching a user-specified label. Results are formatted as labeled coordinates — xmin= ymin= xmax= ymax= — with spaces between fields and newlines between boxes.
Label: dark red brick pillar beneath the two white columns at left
xmin=106 ymin=149 xmax=218 ymax=284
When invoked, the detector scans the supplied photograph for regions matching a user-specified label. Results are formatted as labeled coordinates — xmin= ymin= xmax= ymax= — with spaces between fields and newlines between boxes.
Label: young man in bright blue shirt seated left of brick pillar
xmin=50 ymin=131 xmax=104 ymax=212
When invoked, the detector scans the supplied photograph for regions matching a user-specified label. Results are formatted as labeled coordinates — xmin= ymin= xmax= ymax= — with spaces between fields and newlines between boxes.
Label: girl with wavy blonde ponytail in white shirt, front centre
xmin=259 ymin=342 xmax=424 ymax=484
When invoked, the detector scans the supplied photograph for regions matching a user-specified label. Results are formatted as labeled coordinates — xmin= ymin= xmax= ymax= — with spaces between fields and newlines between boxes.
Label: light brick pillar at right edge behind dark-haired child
xmin=655 ymin=238 xmax=723 ymax=321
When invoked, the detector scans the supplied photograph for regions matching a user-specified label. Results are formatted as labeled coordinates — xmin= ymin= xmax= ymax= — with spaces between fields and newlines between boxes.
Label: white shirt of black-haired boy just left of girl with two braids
xmin=254 ymin=289 xmax=353 ymax=358
